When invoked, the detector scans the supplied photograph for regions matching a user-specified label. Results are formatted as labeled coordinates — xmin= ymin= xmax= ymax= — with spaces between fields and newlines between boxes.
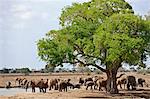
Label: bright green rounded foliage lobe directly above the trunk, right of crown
xmin=94 ymin=14 xmax=144 ymax=64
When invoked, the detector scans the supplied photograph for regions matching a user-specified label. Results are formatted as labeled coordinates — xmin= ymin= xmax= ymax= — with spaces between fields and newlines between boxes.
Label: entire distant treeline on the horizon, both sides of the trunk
xmin=0 ymin=67 xmax=150 ymax=74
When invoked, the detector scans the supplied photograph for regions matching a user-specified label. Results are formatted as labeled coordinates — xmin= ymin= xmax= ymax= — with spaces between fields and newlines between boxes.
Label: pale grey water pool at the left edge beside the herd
xmin=0 ymin=88 xmax=39 ymax=96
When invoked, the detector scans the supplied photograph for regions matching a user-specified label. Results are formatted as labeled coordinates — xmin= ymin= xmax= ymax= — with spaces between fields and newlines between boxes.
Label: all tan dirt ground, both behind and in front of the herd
xmin=0 ymin=72 xmax=150 ymax=99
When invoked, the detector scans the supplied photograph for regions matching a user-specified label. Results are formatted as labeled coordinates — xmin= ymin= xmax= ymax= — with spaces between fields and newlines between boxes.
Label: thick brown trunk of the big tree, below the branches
xmin=106 ymin=69 xmax=118 ymax=94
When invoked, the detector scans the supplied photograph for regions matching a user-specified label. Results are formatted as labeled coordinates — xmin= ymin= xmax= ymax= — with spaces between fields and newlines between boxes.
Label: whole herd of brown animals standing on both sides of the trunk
xmin=6 ymin=76 xmax=149 ymax=93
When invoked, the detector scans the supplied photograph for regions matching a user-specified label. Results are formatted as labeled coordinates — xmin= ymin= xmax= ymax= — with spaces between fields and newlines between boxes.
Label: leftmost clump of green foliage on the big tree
xmin=37 ymin=30 xmax=73 ymax=65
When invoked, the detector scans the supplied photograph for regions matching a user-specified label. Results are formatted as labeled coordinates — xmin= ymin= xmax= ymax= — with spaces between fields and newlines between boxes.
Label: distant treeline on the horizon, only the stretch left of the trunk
xmin=0 ymin=67 xmax=102 ymax=74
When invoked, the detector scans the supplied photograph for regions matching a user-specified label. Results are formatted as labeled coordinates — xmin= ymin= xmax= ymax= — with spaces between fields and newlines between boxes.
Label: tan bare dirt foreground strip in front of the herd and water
xmin=0 ymin=89 xmax=150 ymax=99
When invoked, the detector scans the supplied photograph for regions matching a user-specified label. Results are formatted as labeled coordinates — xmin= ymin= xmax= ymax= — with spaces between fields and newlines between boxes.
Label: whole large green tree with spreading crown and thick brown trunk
xmin=37 ymin=0 xmax=150 ymax=93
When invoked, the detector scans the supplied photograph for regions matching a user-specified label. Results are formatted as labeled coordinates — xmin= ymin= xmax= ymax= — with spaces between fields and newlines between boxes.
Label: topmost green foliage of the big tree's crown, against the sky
xmin=60 ymin=0 xmax=133 ymax=28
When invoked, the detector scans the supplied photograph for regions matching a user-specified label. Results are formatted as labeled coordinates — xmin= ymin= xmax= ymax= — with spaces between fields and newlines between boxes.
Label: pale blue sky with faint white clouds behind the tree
xmin=0 ymin=0 xmax=150 ymax=69
